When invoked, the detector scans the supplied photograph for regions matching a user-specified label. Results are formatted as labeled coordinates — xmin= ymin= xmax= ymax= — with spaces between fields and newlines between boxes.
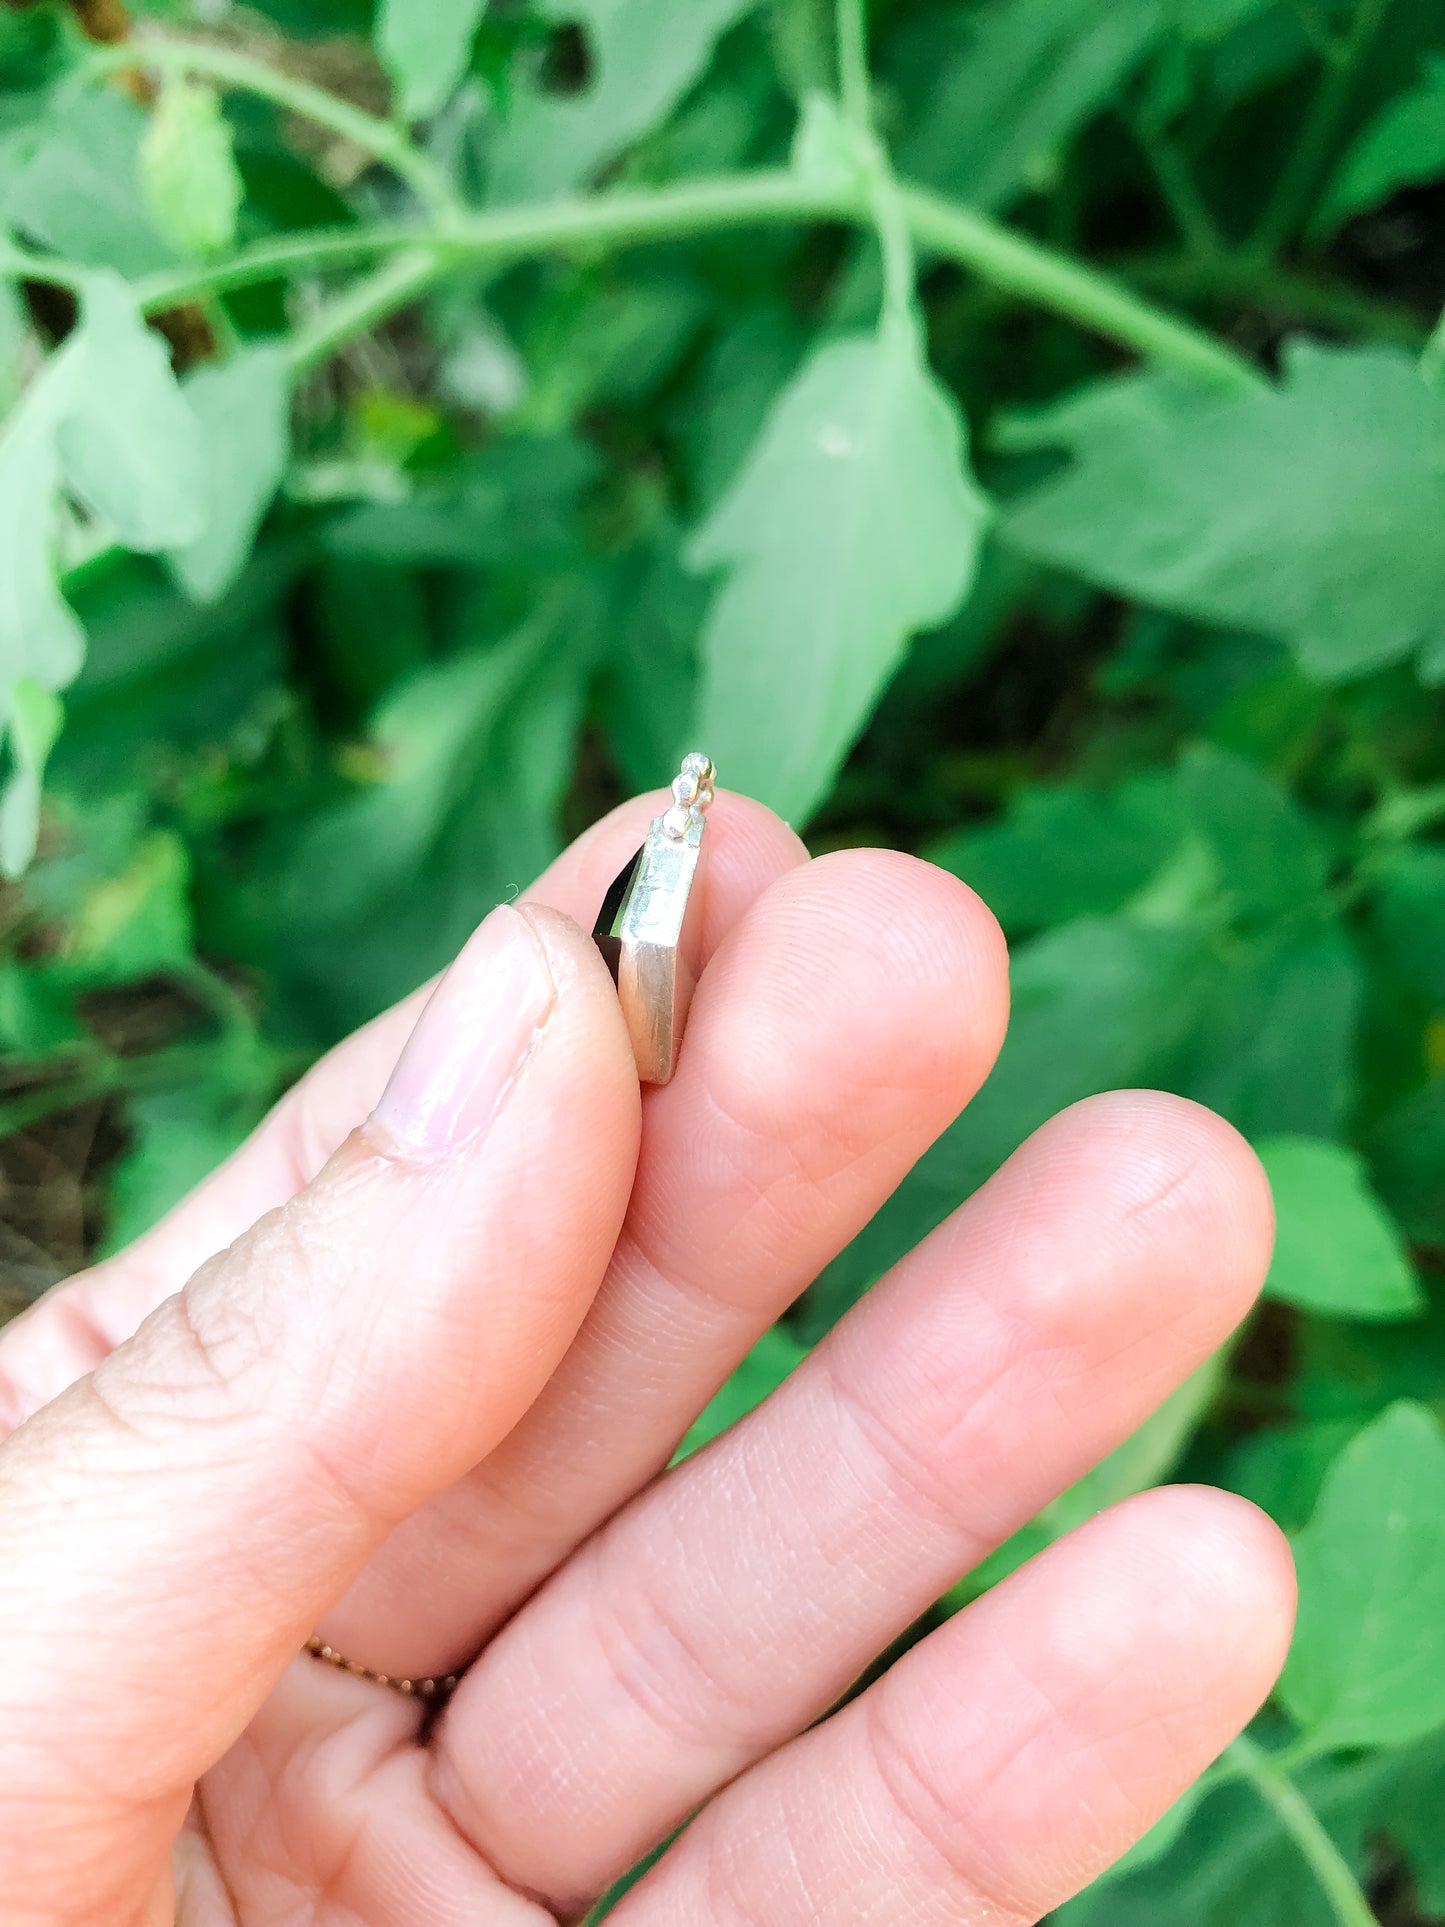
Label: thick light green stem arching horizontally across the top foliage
xmin=121 ymin=170 xmax=1264 ymax=389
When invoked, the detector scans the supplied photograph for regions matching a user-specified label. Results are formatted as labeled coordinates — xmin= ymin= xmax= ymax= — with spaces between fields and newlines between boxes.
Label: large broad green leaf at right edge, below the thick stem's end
xmin=1002 ymin=341 xmax=1445 ymax=680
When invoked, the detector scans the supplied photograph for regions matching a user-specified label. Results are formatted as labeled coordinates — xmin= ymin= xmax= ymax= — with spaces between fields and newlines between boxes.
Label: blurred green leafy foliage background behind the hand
xmin=0 ymin=0 xmax=1445 ymax=1927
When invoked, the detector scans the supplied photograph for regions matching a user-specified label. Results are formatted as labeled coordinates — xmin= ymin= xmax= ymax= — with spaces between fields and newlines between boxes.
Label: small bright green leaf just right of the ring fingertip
xmin=1254 ymin=1137 xmax=1424 ymax=1318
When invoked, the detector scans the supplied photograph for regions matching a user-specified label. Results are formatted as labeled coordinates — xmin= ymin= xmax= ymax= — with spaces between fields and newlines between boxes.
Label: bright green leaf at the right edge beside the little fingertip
xmin=1279 ymin=1401 xmax=1445 ymax=1748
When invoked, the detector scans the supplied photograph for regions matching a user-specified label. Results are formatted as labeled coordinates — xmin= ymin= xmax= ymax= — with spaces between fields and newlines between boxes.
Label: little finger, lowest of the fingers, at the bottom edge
xmin=611 ymin=1488 xmax=1295 ymax=1927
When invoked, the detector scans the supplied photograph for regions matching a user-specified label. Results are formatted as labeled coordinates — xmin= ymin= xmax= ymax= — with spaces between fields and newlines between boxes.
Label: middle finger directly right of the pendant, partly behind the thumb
xmin=326 ymin=850 xmax=1008 ymax=1673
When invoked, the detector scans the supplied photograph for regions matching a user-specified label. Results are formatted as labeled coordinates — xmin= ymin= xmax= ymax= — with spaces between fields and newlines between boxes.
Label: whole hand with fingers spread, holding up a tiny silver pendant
xmin=0 ymin=796 xmax=1293 ymax=1927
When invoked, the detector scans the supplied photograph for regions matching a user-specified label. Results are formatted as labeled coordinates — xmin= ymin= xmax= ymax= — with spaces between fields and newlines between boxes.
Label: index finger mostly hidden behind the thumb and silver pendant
xmin=0 ymin=790 xmax=807 ymax=1434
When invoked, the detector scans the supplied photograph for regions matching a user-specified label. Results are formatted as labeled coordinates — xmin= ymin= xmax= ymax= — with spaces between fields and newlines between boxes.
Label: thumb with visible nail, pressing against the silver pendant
xmin=0 ymin=908 xmax=640 ymax=1919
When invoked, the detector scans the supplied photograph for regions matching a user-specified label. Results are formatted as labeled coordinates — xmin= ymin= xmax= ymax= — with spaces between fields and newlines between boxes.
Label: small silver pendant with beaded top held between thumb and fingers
xmin=591 ymin=753 xmax=715 ymax=1083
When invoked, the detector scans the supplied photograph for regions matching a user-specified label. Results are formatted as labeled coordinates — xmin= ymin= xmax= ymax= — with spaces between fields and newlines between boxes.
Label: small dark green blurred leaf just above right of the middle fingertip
xmin=923 ymin=775 xmax=1187 ymax=931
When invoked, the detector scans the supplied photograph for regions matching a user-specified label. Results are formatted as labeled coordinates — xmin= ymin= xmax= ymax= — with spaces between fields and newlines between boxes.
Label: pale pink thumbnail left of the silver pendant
xmin=372 ymin=904 xmax=557 ymax=1152
